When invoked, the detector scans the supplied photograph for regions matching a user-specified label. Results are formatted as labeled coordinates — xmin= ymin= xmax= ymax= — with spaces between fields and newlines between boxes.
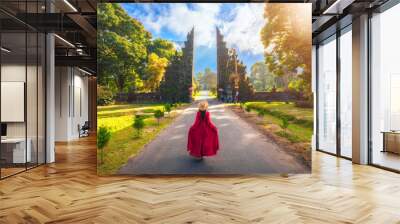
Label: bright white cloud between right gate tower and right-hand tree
xmin=221 ymin=3 xmax=266 ymax=54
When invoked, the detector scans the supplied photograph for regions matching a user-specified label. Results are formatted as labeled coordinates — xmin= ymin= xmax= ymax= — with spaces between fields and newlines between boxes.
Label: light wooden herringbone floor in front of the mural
xmin=0 ymin=138 xmax=400 ymax=224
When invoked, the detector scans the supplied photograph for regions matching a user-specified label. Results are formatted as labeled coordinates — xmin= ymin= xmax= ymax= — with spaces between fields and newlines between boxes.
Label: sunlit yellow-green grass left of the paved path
xmin=97 ymin=104 xmax=184 ymax=175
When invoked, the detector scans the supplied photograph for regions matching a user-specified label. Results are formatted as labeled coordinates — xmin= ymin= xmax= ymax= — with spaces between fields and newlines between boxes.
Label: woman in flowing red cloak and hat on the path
xmin=187 ymin=101 xmax=219 ymax=159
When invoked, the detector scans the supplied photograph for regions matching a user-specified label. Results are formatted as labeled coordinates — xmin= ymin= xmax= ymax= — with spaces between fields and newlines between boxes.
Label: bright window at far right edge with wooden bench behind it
xmin=370 ymin=4 xmax=400 ymax=170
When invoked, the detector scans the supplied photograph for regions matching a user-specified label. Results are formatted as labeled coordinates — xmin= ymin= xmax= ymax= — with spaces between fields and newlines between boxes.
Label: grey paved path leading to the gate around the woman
xmin=119 ymin=92 xmax=308 ymax=174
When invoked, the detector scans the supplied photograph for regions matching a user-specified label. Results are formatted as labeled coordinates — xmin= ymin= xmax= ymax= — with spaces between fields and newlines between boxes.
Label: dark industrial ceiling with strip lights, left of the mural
xmin=0 ymin=0 xmax=97 ymax=74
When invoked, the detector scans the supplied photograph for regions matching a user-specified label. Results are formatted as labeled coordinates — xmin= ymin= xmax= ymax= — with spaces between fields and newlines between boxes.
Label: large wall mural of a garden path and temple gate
xmin=97 ymin=3 xmax=313 ymax=175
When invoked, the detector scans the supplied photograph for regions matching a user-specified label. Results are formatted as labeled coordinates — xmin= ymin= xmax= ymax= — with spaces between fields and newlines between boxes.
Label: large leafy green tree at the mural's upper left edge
xmin=97 ymin=3 xmax=151 ymax=98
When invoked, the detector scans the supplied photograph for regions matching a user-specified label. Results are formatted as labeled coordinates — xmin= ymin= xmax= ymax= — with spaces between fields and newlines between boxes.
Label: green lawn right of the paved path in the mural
xmin=245 ymin=102 xmax=313 ymax=143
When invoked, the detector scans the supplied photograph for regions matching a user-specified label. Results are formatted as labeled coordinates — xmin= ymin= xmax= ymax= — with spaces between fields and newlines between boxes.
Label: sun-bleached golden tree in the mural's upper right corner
xmin=261 ymin=3 xmax=312 ymax=100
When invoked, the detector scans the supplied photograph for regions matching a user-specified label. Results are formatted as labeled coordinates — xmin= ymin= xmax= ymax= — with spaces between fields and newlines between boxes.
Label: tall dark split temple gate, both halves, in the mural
xmin=160 ymin=28 xmax=254 ymax=103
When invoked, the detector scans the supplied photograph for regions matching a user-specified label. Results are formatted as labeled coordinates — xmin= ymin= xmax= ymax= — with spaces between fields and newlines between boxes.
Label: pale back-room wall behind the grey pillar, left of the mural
xmin=55 ymin=67 xmax=88 ymax=141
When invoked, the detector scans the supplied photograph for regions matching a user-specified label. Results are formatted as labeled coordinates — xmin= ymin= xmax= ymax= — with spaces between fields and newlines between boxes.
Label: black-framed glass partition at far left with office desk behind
xmin=0 ymin=1 xmax=46 ymax=178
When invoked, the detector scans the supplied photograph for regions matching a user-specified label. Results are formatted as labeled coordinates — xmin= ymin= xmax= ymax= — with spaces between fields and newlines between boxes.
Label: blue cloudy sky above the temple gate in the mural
xmin=121 ymin=3 xmax=266 ymax=74
